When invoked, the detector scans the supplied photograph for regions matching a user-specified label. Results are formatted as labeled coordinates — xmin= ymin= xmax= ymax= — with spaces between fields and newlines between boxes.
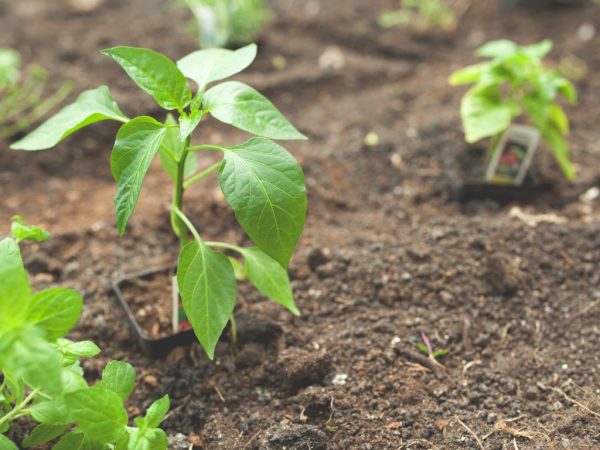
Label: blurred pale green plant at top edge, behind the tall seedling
xmin=184 ymin=0 xmax=271 ymax=48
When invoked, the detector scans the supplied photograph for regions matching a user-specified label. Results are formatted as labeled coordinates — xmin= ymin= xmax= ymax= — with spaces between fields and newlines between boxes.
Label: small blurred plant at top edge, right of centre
xmin=379 ymin=0 xmax=456 ymax=30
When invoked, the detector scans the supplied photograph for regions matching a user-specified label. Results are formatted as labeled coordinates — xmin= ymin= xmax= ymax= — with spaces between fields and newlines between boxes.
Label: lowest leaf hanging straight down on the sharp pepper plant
xmin=177 ymin=241 xmax=237 ymax=359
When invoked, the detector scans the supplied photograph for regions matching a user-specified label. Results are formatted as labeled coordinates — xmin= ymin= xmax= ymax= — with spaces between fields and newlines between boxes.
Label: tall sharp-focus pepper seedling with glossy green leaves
xmin=12 ymin=44 xmax=306 ymax=359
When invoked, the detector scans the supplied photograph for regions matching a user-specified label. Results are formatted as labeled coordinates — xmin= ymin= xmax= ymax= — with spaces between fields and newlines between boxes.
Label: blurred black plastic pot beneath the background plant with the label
xmin=444 ymin=147 xmax=554 ymax=203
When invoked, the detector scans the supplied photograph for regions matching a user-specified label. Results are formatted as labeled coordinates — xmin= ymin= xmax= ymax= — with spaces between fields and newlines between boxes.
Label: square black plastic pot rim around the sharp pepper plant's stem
xmin=112 ymin=266 xmax=196 ymax=357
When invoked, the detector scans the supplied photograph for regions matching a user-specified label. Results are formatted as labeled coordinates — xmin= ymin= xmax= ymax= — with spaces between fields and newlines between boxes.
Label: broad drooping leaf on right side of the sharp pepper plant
xmin=219 ymin=138 xmax=306 ymax=268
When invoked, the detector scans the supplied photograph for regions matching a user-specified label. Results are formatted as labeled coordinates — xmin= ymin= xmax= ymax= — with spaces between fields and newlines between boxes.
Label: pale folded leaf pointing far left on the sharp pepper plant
xmin=10 ymin=86 xmax=128 ymax=150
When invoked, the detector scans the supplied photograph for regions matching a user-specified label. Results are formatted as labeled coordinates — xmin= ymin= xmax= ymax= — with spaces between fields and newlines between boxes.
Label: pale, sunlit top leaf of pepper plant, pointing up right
xmin=177 ymin=44 xmax=256 ymax=91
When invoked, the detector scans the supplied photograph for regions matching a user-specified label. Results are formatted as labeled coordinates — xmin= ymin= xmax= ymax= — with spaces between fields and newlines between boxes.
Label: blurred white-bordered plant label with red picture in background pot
xmin=485 ymin=125 xmax=540 ymax=186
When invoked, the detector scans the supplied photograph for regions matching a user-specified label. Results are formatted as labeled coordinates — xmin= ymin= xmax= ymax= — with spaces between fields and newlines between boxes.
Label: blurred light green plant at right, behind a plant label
xmin=449 ymin=40 xmax=577 ymax=180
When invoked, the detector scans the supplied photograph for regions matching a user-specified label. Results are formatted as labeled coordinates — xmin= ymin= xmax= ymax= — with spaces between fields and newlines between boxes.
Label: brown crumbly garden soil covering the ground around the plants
xmin=0 ymin=0 xmax=600 ymax=449
